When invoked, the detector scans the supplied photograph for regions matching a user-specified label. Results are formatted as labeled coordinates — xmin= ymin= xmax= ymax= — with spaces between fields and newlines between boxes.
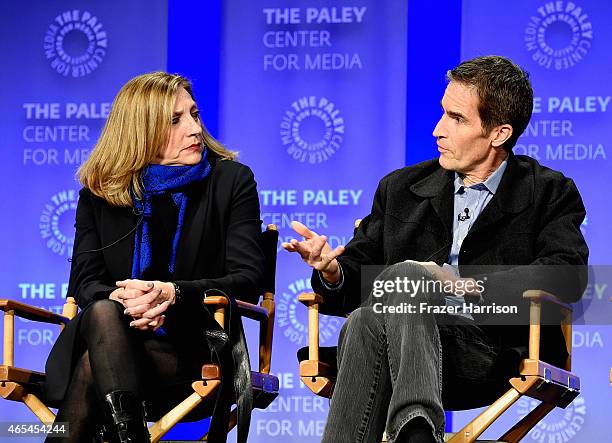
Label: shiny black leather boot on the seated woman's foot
xmin=104 ymin=391 xmax=151 ymax=443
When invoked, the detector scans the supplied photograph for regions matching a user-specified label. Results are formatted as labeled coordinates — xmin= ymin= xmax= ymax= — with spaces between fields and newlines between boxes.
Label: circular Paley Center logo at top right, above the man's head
xmin=524 ymin=1 xmax=593 ymax=71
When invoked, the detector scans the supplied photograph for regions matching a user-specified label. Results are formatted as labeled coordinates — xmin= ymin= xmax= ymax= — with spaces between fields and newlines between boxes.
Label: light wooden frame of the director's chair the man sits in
xmin=298 ymin=290 xmax=580 ymax=443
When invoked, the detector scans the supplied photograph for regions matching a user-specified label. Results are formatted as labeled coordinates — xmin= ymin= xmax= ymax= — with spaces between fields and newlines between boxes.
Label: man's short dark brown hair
xmin=446 ymin=55 xmax=533 ymax=151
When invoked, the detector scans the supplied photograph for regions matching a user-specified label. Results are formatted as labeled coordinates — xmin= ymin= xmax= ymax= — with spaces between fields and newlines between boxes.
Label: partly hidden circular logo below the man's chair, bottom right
xmin=516 ymin=396 xmax=586 ymax=442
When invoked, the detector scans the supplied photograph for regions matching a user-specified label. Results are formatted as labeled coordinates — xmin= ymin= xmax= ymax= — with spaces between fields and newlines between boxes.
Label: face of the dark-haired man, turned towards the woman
xmin=433 ymin=82 xmax=494 ymax=174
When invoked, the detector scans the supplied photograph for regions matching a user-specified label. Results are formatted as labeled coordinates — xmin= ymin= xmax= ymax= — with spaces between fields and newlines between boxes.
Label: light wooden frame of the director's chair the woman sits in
xmin=0 ymin=225 xmax=279 ymax=443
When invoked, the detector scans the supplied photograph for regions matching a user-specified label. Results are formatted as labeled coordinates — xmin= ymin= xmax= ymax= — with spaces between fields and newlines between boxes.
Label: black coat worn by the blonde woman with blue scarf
xmin=45 ymin=156 xmax=265 ymax=401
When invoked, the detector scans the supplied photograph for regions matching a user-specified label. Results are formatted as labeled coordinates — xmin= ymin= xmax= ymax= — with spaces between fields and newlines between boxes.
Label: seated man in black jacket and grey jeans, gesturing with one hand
xmin=283 ymin=56 xmax=588 ymax=443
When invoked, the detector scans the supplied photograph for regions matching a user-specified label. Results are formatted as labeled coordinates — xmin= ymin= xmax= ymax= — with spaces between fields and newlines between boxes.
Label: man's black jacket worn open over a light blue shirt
xmin=312 ymin=154 xmax=588 ymax=360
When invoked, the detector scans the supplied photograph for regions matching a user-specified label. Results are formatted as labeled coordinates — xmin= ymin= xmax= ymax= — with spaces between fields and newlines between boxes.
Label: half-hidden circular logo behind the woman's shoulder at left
xmin=38 ymin=190 xmax=79 ymax=257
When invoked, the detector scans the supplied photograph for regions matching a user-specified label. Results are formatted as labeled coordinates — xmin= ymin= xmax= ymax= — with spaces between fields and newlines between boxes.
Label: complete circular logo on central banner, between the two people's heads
xmin=280 ymin=96 xmax=344 ymax=164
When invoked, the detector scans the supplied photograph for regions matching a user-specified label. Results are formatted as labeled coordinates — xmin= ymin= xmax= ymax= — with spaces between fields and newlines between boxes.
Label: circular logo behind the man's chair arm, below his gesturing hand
xmin=275 ymin=278 xmax=342 ymax=346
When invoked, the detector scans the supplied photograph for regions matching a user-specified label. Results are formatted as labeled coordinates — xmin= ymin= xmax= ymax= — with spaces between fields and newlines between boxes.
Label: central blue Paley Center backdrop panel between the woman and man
xmin=219 ymin=0 xmax=407 ymax=442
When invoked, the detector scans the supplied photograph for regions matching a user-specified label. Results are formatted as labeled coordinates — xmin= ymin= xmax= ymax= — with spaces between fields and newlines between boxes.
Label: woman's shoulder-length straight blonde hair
xmin=77 ymin=72 xmax=236 ymax=207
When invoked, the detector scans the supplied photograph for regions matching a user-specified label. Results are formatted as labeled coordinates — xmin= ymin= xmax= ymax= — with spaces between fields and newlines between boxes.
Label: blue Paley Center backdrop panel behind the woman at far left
xmin=0 ymin=0 xmax=168 ymax=441
